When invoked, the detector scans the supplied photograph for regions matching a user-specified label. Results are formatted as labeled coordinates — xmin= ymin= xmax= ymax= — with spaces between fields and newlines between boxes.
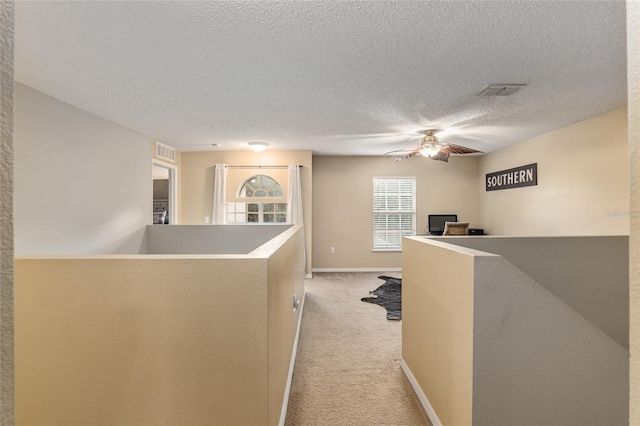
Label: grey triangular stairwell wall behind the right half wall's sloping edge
xmin=434 ymin=236 xmax=629 ymax=350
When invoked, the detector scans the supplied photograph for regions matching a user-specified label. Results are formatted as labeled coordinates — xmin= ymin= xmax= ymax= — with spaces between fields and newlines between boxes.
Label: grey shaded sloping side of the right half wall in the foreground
xmin=472 ymin=252 xmax=629 ymax=426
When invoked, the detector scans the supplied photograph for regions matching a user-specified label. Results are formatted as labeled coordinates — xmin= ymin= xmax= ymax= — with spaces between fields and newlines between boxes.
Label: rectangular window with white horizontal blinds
xmin=373 ymin=176 xmax=416 ymax=251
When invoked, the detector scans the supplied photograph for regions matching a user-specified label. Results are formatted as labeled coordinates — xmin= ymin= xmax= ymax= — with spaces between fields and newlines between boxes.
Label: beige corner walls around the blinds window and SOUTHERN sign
xmin=313 ymin=108 xmax=630 ymax=270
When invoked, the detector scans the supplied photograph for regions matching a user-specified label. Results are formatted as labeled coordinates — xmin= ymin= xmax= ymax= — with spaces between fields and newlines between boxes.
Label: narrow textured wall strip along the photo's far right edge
xmin=627 ymin=1 xmax=640 ymax=425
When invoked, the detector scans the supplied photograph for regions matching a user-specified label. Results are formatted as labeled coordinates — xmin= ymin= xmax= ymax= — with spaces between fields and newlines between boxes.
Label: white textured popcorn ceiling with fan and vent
xmin=15 ymin=1 xmax=627 ymax=155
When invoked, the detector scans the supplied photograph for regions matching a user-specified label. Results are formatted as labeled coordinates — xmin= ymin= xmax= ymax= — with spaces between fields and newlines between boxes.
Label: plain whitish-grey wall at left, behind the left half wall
xmin=14 ymin=84 xmax=152 ymax=254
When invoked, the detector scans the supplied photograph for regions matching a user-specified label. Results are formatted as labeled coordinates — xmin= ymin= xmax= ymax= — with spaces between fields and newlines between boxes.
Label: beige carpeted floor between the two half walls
xmin=285 ymin=272 xmax=431 ymax=426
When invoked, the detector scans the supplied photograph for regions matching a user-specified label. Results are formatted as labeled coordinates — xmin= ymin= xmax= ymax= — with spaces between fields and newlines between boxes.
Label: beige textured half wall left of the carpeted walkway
xmin=15 ymin=227 xmax=304 ymax=426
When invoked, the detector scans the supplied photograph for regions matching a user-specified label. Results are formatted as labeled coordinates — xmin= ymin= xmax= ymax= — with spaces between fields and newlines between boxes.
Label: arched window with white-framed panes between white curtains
xmin=226 ymin=175 xmax=287 ymax=223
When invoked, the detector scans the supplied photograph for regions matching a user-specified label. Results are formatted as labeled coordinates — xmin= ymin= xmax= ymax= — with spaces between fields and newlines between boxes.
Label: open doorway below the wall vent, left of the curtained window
xmin=151 ymin=159 xmax=180 ymax=225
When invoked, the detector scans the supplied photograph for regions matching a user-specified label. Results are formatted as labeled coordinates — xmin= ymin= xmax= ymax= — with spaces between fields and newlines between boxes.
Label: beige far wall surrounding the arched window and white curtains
xmin=180 ymin=150 xmax=313 ymax=274
